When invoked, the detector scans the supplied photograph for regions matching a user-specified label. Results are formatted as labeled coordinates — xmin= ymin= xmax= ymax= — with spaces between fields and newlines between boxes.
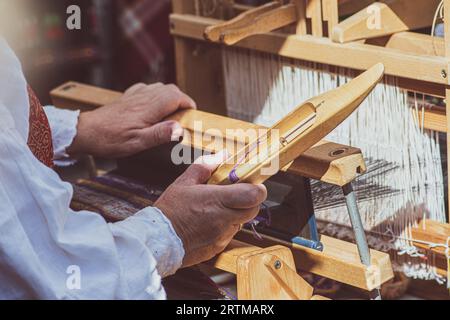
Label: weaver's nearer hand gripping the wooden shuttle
xmin=155 ymin=153 xmax=267 ymax=267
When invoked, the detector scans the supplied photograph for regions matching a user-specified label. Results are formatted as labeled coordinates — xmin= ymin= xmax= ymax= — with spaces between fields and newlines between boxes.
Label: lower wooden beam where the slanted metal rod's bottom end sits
xmin=236 ymin=230 xmax=394 ymax=291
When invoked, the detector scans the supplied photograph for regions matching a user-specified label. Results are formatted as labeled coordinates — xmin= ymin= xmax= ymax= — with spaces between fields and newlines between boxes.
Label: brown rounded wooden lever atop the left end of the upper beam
xmin=204 ymin=1 xmax=298 ymax=45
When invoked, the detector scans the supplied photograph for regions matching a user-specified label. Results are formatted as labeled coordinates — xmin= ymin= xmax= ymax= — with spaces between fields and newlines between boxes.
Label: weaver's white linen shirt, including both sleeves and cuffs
xmin=0 ymin=37 xmax=184 ymax=299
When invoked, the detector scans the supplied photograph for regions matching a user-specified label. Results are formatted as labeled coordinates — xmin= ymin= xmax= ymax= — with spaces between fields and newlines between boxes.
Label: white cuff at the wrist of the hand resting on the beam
xmin=44 ymin=106 xmax=80 ymax=167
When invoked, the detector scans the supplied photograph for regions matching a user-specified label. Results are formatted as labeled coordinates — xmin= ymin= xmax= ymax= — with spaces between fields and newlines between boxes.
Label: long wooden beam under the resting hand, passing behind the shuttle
xmin=51 ymin=82 xmax=366 ymax=186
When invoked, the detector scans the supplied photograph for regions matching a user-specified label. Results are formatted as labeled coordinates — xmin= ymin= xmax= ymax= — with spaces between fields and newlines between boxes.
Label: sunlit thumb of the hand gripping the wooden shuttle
xmin=176 ymin=150 xmax=228 ymax=186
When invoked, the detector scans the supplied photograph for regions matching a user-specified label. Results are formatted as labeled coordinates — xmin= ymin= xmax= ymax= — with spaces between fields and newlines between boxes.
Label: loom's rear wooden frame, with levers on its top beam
xmin=171 ymin=0 xmax=450 ymax=296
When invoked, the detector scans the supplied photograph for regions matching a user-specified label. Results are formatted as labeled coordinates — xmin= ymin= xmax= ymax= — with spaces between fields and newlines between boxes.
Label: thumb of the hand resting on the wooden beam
xmin=140 ymin=121 xmax=184 ymax=148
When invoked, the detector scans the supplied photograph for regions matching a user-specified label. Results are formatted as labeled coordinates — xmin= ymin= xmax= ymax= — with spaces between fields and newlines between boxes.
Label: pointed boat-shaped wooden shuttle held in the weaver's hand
xmin=208 ymin=64 xmax=384 ymax=185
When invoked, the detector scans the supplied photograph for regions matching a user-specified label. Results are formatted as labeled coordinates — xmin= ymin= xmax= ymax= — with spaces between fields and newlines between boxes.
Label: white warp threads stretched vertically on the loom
xmin=223 ymin=48 xmax=445 ymax=281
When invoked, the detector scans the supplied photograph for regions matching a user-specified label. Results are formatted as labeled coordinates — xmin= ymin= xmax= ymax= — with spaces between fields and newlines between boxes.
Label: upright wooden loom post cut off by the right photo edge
xmin=442 ymin=0 xmax=450 ymax=222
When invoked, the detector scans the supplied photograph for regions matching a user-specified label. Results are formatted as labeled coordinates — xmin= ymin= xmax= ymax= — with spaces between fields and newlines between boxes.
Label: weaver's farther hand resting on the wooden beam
xmin=67 ymin=83 xmax=196 ymax=158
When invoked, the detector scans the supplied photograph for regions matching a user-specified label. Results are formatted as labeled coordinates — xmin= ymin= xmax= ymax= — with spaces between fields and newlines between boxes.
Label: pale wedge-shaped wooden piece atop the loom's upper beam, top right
xmin=331 ymin=0 xmax=440 ymax=43
